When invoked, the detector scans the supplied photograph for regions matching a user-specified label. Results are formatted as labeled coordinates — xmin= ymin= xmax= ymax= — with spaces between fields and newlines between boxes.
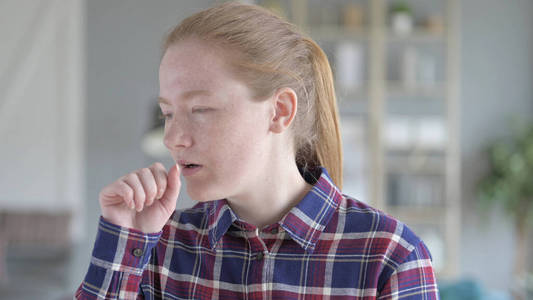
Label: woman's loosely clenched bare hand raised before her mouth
xmin=99 ymin=163 xmax=181 ymax=233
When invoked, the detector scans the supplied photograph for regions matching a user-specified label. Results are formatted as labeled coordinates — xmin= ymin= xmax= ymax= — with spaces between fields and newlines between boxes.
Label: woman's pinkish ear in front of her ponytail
xmin=270 ymin=87 xmax=298 ymax=133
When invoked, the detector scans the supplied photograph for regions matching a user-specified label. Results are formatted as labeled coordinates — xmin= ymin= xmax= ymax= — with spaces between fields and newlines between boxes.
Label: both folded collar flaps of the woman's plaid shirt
xmin=207 ymin=167 xmax=342 ymax=252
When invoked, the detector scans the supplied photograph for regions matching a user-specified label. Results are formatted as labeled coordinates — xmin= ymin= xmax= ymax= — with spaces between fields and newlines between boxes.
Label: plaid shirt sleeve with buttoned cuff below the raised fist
xmin=75 ymin=216 xmax=162 ymax=299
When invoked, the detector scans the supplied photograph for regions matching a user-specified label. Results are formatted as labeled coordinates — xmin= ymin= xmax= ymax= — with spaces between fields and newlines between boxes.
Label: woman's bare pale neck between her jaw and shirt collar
xmin=228 ymin=160 xmax=312 ymax=228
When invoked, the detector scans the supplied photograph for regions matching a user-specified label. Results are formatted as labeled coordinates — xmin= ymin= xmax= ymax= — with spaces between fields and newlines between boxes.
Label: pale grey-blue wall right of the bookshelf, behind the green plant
xmin=461 ymin=0 xmax=533 ymax=288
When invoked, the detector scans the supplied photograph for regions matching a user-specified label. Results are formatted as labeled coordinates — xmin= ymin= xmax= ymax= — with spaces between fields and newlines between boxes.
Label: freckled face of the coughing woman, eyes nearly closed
xmin=159 ymin=39 xmax=272 ymax=201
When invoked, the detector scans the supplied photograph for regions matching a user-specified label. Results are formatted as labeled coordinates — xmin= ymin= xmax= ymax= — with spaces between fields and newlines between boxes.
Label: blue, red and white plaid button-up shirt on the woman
xmin=75 ymin=168 xmax=439 ymax=299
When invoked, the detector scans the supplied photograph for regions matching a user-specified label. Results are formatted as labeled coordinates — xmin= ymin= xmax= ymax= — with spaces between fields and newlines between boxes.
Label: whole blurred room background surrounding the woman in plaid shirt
xmin=0 ymin=0 xmax=533 ymax=299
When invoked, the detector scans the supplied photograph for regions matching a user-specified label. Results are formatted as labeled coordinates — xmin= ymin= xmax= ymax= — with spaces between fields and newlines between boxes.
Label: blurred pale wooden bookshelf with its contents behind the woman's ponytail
xmin=254 ymin=0 xmax=461 ymax=278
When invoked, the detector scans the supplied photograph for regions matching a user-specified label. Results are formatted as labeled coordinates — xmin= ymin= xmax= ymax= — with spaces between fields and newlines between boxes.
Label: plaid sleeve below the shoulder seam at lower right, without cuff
xmin=378 ymin=241 xmax=439 ymax=300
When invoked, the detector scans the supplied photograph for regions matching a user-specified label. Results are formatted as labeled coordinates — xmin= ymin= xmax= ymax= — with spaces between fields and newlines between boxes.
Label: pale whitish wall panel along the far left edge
xmin=0 ymin=0 xmax=85 ymax=241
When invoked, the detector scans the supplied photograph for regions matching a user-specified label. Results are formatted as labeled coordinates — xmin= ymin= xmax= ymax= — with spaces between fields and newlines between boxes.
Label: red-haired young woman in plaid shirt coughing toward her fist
xmin=76 ymin=2 xmax=438 ymax=299
